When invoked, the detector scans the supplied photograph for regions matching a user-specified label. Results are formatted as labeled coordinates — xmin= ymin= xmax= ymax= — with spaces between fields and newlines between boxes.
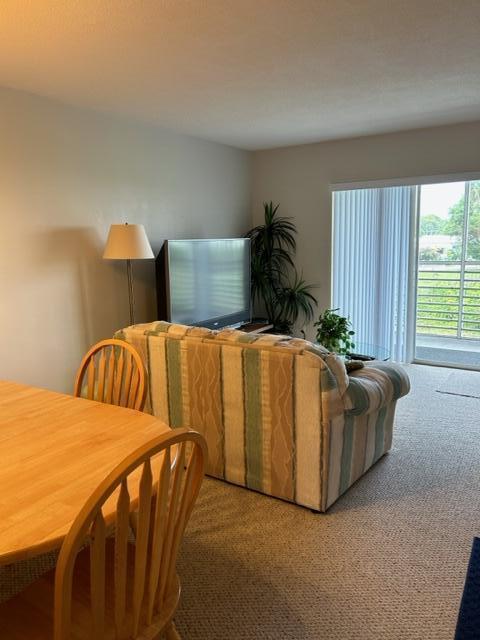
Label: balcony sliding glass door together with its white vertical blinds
xmin=332 ymin=180 xmax=480 ymax=369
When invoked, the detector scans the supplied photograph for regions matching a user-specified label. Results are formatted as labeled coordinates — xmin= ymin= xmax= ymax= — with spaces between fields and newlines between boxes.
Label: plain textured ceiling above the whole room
xmin=0 ymin=0 xmax=480 ymax=149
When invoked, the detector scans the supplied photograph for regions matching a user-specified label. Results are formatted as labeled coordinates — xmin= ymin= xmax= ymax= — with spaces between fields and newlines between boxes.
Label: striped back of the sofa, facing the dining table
xmin=116 ymin=322 xmax=347 ymax=504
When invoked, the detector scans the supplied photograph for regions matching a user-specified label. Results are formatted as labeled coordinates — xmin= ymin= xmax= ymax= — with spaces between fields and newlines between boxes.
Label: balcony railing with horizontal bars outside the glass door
xmin=417 ymin=261 xmax=480 ymax=340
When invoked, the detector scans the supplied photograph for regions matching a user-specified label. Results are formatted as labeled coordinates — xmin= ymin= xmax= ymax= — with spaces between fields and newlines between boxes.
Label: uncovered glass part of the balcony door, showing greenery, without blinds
xmin=415 ymin=181 xmax=480 ymax=368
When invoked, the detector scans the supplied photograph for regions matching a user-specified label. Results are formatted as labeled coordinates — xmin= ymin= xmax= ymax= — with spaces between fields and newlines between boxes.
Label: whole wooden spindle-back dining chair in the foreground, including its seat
xmin=0 ymin=429 xmax=206 ymax=640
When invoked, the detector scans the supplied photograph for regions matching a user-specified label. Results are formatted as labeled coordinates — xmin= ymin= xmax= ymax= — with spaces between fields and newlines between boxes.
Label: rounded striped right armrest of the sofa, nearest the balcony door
xmin=343 ymin=361 xmax=410 ymax=416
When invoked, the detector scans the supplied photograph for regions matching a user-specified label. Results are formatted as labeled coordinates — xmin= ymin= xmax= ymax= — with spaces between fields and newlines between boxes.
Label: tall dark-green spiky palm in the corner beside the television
xmin=246 ymin=201 xmax=317 ymax=333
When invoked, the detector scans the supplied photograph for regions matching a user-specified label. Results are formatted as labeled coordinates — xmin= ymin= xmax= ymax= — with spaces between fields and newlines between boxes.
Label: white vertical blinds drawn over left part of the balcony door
xmin=332 ymin=186 xmax=416 ymax=362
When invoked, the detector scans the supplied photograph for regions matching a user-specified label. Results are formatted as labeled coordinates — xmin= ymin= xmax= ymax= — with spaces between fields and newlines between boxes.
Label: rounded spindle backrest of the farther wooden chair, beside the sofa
xmin=74 ymin=339 xmax=147 ymax=411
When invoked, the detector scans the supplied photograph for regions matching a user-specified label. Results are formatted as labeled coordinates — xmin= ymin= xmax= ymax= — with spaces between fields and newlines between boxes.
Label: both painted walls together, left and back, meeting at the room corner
xmin=4 ymin=89 xmax=480 ymax=391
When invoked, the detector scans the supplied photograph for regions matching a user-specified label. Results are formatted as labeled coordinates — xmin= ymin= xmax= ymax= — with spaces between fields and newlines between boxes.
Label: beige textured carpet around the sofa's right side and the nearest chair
xmin=176 ymin=365 xmax=480 ymax=640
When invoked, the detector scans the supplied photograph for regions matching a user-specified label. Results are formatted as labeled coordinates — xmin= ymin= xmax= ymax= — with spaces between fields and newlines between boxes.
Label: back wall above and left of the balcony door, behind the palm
xmin=253 ymin=122 xmax=480 ymax=335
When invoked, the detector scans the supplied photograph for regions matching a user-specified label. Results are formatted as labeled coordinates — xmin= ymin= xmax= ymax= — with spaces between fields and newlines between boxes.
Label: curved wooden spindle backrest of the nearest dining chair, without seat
xmin=54 ymin=429 xmax=207 ymax=640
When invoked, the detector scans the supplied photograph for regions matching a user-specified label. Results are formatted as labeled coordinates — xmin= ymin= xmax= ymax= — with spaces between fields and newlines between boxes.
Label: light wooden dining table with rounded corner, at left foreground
xmin=0 ymin=382 xmax=170 ymax=567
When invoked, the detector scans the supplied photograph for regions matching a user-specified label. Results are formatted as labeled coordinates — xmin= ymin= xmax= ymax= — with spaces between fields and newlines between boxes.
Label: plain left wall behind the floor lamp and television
xmin=0 ymin=90 xmax=251 ymax=391
